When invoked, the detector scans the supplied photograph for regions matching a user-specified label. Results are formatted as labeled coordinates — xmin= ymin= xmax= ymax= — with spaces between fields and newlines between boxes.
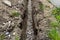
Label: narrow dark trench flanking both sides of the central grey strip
xmin=20 ymin=1 xmax=43 ymax=40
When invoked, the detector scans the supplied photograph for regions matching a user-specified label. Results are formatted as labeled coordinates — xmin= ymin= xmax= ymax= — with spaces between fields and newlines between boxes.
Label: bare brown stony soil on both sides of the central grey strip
xmin=0 ymin=0 xmax=55 ymax=40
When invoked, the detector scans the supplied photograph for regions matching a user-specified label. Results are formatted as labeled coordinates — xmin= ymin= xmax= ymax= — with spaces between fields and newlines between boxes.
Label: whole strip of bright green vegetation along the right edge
xmin=48 ymin=8 xmax=60 ymax=40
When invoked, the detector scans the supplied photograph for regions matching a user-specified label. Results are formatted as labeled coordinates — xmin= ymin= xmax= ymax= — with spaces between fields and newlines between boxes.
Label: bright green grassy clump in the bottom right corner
xmin=48 ymin=28 xmax=60 ymax=40
